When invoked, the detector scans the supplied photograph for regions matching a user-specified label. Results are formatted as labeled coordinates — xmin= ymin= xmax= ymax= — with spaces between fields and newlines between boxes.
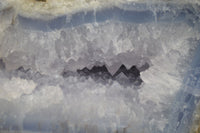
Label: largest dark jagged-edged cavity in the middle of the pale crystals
xmin=62 ymin=64 xmax=149 ymax=86
